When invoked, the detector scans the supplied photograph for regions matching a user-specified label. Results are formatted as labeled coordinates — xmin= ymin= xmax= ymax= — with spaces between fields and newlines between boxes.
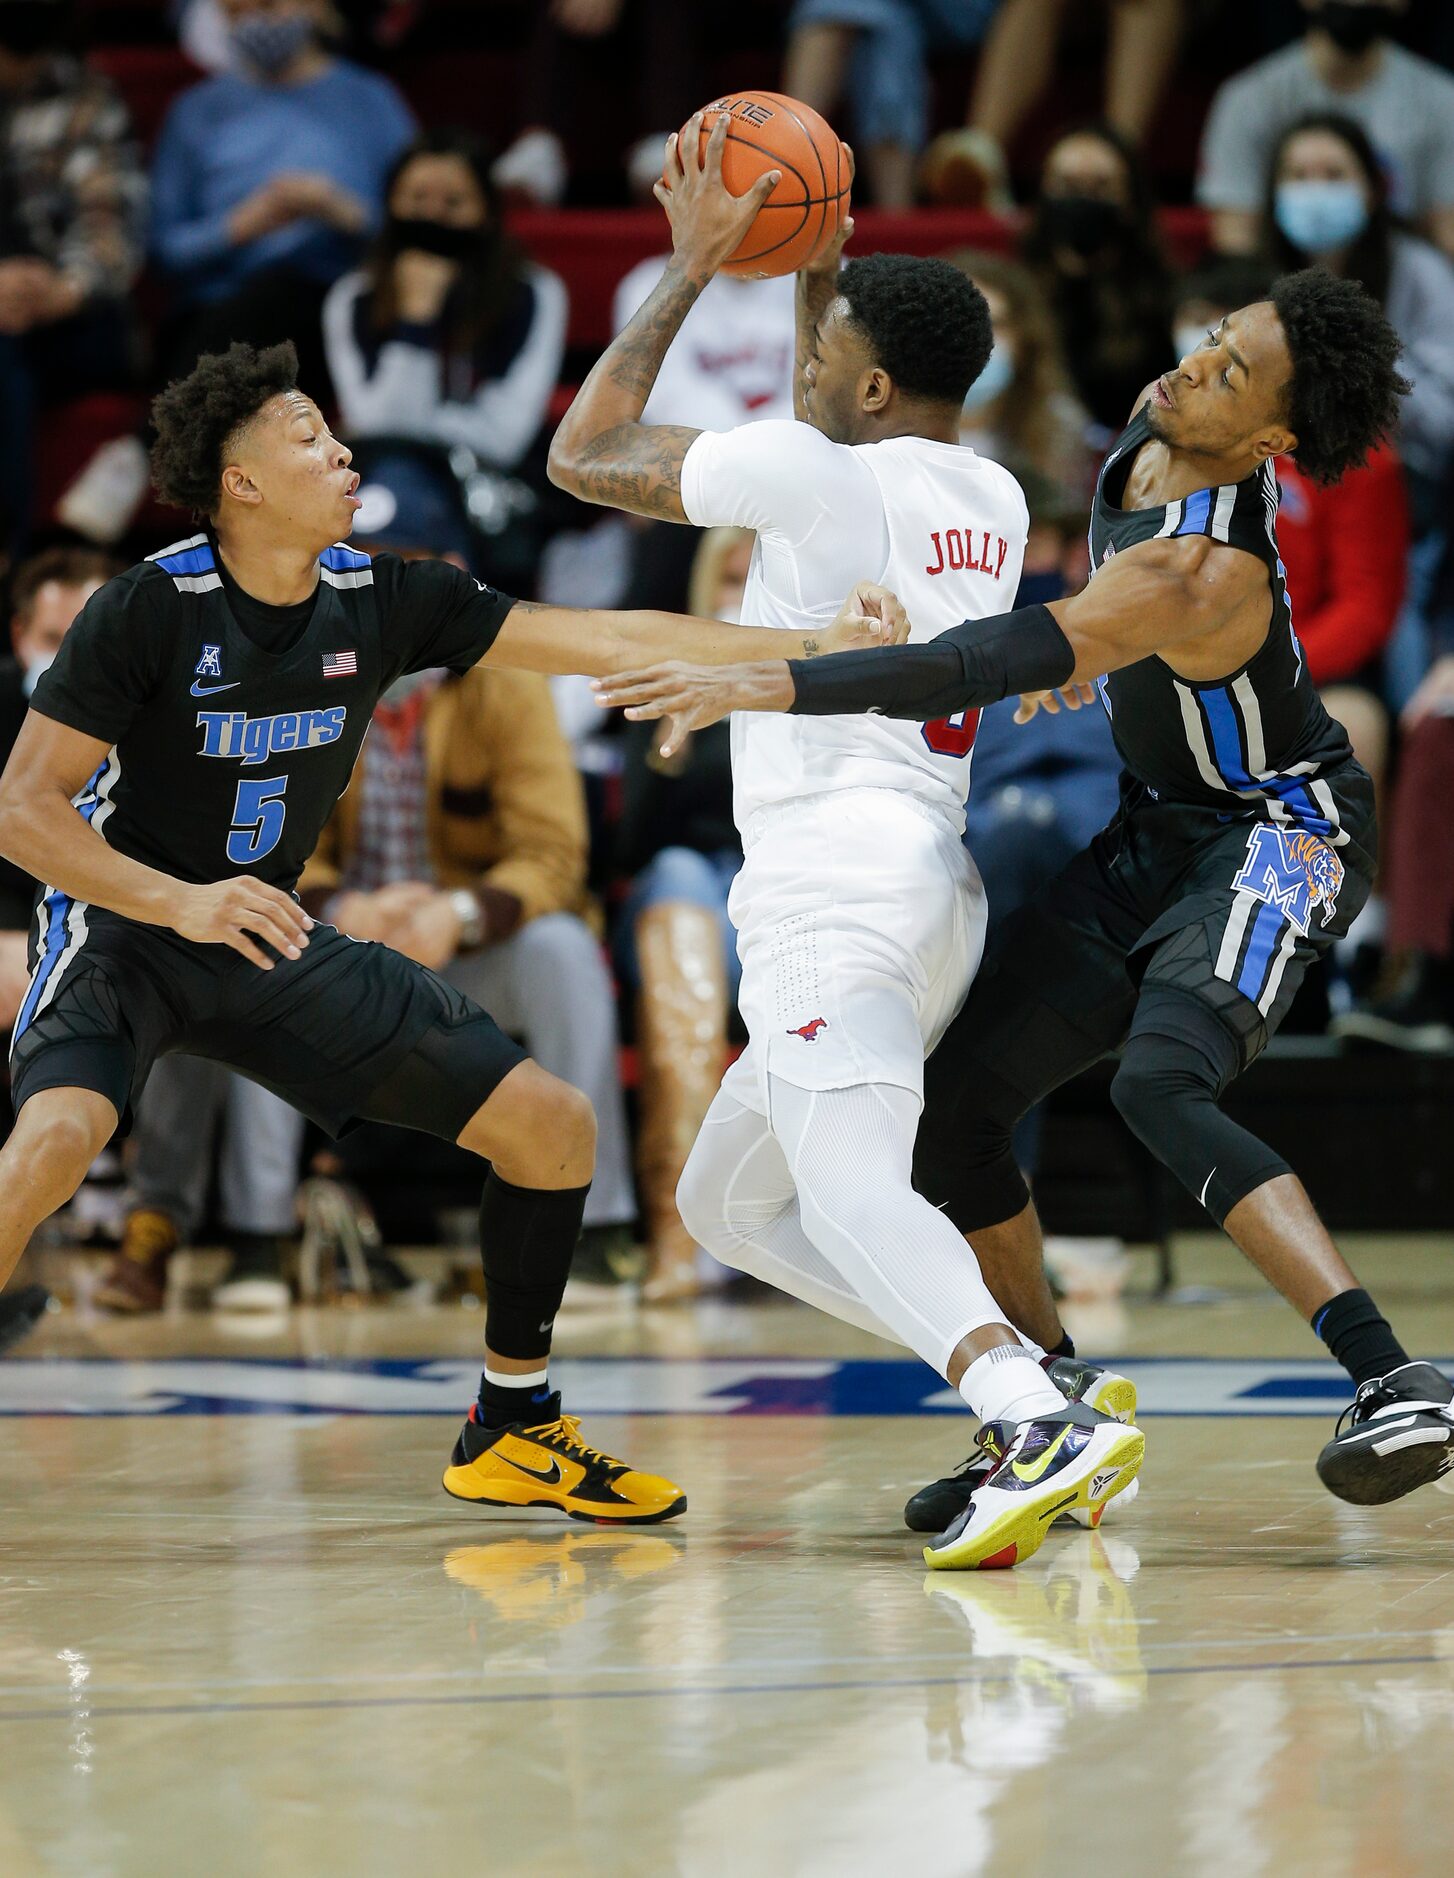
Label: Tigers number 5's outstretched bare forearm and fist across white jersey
xmin=485 ymin=580 xmax=909 ymax=678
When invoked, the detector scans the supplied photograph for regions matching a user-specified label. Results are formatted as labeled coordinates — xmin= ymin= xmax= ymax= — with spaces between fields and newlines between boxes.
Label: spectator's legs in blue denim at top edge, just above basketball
xmin=783 ymin=0 xmax=1016 ymax=208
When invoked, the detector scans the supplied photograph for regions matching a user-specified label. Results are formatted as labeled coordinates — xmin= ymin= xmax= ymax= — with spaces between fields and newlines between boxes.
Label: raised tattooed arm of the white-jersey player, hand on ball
xmin=549 ymin=113 xmax=778 ymax=522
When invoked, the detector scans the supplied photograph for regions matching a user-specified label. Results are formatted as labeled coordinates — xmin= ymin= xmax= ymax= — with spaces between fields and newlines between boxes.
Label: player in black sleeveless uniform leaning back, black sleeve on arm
xmin=609 ymin=269 xmax=1454 ymax=1527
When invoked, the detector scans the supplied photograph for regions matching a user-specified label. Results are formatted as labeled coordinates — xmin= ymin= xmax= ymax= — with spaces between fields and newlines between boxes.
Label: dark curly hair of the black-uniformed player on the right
xmin=1268 ymin=267 xmax=1413 ymax=485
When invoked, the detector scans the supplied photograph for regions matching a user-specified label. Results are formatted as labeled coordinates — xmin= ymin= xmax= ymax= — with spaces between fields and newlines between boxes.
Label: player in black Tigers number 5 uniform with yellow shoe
xmin=0 ymin=346 xmax=883 ymax=1523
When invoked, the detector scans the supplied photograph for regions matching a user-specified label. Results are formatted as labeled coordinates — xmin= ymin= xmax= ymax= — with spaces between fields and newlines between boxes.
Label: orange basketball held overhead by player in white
xmin=665 ymin=92 xmax=849 ymax=274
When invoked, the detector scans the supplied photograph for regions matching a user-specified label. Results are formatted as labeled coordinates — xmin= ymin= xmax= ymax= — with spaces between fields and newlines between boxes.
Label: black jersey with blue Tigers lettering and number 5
xmin=32 ymin=535 xmax=513 ymax=893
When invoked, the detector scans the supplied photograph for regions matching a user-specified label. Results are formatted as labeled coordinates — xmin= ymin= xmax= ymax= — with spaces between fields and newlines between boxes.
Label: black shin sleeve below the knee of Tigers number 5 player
xmin=479 ymin=1172 xmax=590 ymax=1367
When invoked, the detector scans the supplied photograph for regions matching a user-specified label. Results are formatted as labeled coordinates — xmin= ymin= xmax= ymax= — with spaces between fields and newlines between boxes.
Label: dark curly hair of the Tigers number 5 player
xmin=152 ymin=340 xmax=299 ymax=516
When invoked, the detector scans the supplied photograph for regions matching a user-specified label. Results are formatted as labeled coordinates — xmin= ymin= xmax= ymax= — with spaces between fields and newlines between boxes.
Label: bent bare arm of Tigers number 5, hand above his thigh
xmin=0 ymin=710 xmax=314 ymax=971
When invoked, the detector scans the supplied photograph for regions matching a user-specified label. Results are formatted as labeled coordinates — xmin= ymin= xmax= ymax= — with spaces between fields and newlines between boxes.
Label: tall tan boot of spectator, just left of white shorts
xmin=637 ymin=900 xmax=727 ymax=1301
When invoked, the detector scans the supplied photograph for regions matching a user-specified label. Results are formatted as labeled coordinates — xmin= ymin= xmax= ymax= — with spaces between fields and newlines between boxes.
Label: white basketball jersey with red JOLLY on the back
xmin=682 ymin=423 xmax=1029 ymax=832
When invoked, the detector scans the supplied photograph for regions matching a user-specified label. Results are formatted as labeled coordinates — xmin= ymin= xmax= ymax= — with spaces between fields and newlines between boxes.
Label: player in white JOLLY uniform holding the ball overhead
xmin=550 ymin=118 xmax=1142 ymax=1568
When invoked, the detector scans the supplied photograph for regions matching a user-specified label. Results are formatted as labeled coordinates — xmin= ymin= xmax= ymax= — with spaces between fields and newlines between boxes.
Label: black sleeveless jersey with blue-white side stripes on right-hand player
xmin=1090 ymin=406 xmax=1353 ymax=843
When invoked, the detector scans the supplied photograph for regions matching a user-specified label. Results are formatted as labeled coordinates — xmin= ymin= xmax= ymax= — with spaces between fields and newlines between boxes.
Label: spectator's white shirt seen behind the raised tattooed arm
xmin=611 ymin=255 xmax=795 ymax=430
